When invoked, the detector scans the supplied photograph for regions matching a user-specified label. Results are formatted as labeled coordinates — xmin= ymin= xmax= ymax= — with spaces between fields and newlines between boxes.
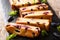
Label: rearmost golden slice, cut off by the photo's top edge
xmin=9 ymin=0 xmax=40 ymax=8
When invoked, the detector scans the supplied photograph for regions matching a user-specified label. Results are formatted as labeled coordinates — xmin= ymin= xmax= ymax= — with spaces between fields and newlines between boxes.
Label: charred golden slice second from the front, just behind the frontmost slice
xmin=16 ymin=18 xmax=50 ymax=30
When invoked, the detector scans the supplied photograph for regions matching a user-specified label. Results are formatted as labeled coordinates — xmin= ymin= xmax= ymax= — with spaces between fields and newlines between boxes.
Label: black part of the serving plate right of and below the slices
xmin=12 ymin=3 xmax=60 ymax=40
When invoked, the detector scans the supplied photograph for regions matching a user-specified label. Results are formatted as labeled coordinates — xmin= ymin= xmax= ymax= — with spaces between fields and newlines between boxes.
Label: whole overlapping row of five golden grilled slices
xmin=6 ymin=0 xmax=53 ymax=37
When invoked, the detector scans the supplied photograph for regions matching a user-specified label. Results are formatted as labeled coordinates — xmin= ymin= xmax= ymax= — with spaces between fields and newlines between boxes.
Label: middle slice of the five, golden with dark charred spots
xmin=21 ymin=10 xmax=53 ymax=20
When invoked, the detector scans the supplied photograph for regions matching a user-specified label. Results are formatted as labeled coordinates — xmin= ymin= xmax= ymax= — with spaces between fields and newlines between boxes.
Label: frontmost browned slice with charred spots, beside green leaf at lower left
xmin=6 ymin=23 xmax=40 ymax=38
